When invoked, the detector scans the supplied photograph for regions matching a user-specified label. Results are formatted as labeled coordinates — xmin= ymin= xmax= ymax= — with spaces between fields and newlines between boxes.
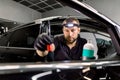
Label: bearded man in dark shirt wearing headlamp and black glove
xmin=34 ymin=18 xmax=87 ymax=61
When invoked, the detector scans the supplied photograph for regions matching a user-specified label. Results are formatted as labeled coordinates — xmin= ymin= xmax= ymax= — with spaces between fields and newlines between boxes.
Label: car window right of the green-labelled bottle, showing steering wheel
xmin=95 ymin=34 xmax=115 ymax=58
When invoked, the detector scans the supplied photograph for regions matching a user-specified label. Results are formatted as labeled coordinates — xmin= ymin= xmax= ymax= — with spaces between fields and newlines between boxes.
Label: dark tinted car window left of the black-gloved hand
xmin=9 ymin=25 xmax=39 ymax=48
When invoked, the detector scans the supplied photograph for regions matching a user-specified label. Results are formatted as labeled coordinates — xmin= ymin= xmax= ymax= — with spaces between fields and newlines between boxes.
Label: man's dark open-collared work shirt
xmin=54 ymin=35 xmax=87 ymax=61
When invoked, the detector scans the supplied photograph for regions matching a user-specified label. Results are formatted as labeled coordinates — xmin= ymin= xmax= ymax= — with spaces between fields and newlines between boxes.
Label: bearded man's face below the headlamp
xmin=63 ymin=22 xmax=80 ymax=43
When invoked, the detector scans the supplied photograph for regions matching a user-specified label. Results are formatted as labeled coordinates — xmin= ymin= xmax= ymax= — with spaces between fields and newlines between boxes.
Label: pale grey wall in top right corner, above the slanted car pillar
xmin=86 ymin=0 xmax=120 ymax=24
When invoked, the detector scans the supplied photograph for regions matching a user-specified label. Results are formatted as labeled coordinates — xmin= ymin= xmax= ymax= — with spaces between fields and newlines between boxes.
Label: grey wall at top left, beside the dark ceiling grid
xmin=0 ymin=0 xmax=41 ymax=23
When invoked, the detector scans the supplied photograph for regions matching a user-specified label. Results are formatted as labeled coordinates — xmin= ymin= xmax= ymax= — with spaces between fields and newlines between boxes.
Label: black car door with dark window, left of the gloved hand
xmin=0 ymin=24 xmax=39 ymax=62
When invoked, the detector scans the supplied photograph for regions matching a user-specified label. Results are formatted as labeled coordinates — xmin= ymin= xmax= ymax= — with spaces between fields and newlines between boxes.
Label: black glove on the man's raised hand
xmin=34 ymin=33 xmax=53 ymax=51
